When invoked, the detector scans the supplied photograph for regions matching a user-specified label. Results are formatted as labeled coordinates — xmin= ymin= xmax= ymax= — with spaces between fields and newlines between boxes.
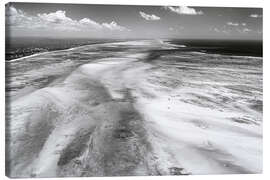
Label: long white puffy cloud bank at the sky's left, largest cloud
xmin=6 ymin=6 xmax=130 ymax=32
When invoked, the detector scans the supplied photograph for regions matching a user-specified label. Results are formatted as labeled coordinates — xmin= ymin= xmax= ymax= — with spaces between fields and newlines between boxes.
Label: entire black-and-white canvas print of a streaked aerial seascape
xmin=5 ymin=2 xmax=263 ymax=178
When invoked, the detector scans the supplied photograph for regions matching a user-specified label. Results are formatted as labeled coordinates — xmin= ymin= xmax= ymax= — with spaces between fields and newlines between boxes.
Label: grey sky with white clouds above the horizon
xmin=6 ymin=3 xmax=263 ymax=40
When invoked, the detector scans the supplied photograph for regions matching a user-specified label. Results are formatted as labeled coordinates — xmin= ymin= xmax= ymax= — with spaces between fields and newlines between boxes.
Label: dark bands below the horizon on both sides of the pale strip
xmin=6 ymin=37 xmax=262 ymax=60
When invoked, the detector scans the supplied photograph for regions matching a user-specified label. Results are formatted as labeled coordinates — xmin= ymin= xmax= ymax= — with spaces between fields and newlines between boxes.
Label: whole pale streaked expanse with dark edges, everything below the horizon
xmin=6 ymin=39 xmax=263 ymax=177
